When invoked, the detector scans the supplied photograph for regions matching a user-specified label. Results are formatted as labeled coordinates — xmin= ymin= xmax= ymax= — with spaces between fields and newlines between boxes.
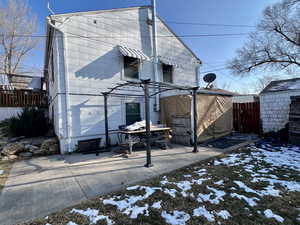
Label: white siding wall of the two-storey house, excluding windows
xmin=50 ymin=7 xmax=198 ymax=153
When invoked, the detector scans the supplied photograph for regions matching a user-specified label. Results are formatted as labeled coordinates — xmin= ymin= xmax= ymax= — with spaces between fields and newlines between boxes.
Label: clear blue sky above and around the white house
xmin=27 ymin=0 xmax=276 ymax=92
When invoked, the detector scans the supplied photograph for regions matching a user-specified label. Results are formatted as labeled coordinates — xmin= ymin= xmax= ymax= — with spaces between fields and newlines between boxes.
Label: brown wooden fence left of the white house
xmin=0 ymin=90 xmax=48 ymax=107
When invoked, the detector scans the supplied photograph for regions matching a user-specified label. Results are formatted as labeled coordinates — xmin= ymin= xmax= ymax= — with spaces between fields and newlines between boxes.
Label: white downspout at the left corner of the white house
xmin=47 ymin=16 xmax=71 ymax=152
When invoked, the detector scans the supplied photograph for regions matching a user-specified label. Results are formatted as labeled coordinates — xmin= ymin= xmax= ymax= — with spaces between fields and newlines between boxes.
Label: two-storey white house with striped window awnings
xmin=44 ymin=6 xmax=201 ymax=153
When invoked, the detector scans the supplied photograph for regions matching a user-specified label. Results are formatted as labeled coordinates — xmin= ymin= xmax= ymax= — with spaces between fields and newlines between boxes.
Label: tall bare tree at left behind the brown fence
xmin=0 ymin=0 xmax=38 ymax=80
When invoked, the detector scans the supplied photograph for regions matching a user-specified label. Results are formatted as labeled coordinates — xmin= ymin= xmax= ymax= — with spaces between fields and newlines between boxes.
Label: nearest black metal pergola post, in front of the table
xmin=142 ymin=79 xmax=153 ymax=167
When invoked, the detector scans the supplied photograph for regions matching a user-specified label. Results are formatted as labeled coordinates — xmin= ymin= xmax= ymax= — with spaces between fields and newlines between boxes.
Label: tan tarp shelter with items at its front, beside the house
xmin=161 ymin=89 xmax=233 ymax=144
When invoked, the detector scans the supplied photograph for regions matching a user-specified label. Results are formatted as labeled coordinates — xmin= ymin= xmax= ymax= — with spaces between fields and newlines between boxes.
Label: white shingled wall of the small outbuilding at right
xmin=260 ymin=90 xmax=300 ymax=133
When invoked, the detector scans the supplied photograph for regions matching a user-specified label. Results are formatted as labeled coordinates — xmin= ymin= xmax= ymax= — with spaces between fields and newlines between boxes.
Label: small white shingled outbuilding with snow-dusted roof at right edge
xmin=259 ymin=78 xmax=300 ymax=133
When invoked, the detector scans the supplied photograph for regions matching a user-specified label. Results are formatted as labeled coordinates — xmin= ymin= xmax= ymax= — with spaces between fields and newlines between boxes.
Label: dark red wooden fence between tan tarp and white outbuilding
xmin=233 ymin=102 xmax=260 ymax=134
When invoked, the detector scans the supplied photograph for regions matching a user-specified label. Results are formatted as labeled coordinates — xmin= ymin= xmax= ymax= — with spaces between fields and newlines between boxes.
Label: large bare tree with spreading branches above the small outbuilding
xmin=229 ymin=0 xmax=300 ymax=74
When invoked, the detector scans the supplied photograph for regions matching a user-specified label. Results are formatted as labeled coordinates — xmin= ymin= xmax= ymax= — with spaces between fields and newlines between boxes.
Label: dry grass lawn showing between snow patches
xmin=19 ymin=148 xmax=300 ymax=225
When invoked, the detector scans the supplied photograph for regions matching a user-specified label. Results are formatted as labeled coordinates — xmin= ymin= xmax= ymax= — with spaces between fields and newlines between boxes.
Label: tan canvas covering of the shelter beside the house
xmin=161 ymin=94 xmax=233 ymax=142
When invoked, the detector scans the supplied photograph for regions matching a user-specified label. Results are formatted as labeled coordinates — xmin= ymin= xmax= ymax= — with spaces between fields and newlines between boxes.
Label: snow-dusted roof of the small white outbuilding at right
xmin=260 ymin=78 xmax=300 ymax=94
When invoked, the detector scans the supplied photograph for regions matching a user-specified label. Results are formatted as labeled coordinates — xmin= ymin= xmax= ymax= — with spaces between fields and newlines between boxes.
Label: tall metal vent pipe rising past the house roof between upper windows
xmin=152 ymin=0 xmax=160 ymax=111
